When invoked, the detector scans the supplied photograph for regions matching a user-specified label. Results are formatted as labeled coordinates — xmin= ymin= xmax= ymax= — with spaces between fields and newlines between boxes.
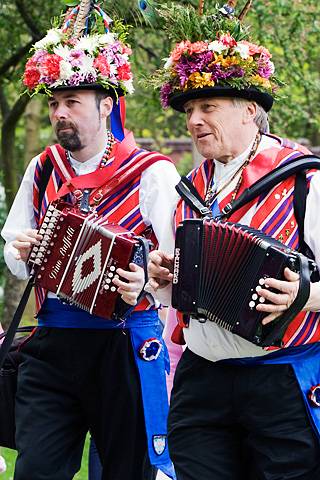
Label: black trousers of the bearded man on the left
xmin=14 ymin=328 xmax=150 ymax=480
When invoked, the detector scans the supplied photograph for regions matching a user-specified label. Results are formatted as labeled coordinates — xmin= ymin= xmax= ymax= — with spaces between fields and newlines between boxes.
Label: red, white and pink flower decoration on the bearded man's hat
xmin=23 ymin=0 xmax=134 ymax=96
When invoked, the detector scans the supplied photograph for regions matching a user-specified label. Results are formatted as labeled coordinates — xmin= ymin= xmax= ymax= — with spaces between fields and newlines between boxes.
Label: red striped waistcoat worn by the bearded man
xmin=33 ymin=141 xmax=171 ymax=312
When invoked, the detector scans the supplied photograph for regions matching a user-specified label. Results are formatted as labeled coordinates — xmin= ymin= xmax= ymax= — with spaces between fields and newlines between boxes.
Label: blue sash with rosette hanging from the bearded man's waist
xmin=38 ymin=298 xmax=176 ymax=480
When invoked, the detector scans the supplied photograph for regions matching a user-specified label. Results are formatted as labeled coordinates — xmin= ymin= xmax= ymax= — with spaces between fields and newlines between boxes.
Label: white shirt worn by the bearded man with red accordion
xmin=1 ymin=146 xmax=180 ymax=297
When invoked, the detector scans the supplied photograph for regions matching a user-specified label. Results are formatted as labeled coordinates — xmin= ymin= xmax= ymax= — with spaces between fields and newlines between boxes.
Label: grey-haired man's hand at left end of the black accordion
xmin=148 ymin=250 xmax=173 ymax=290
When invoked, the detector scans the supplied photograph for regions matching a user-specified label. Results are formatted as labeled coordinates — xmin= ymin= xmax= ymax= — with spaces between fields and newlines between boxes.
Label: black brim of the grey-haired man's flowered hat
xmin=169 ymin=85 xmax=273 ymax=112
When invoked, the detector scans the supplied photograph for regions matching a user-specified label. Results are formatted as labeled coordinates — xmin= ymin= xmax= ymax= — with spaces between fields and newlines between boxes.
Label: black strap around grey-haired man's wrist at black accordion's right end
xmin=261 ymin=254 xmax=310 ymax=347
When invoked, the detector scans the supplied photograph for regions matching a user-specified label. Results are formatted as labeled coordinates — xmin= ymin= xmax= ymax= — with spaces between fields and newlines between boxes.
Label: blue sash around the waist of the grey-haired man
xmin=223 ymin=342 xmax=320 ymax=440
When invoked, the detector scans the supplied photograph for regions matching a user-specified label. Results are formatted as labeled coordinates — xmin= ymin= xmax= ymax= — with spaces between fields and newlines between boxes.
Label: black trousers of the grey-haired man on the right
xmin=168 ymin=350 xmax=320 ymax=480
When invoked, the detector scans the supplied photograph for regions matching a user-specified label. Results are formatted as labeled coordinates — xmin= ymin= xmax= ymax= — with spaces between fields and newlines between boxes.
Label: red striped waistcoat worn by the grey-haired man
xmin=176 ymin=137 xmax=320 ymax=350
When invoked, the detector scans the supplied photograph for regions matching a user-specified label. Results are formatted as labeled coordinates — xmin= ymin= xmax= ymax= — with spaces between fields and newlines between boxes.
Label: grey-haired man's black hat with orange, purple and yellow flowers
xmin=151 ymin=0 xmax=278 ymax=112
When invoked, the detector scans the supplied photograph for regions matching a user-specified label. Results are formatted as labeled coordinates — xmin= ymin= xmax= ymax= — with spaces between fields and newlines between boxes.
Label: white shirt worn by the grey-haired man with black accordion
xmin=155 ymin=136 xmax=320 ymax=361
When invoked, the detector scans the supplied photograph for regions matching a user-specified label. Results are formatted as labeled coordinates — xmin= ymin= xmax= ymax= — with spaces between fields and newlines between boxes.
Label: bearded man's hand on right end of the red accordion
xmin=112 ymin=263 xmax=145 ymax=305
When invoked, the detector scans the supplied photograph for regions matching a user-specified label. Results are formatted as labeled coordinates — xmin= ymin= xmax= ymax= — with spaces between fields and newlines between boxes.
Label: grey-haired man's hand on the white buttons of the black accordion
xmin=256 ymin=268 xmax=299 ymax=325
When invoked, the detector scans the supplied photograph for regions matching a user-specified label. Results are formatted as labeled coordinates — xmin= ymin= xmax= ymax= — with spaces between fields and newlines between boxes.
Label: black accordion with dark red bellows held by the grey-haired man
xmin=172 ymin=219 xmax=318 ymax=346
